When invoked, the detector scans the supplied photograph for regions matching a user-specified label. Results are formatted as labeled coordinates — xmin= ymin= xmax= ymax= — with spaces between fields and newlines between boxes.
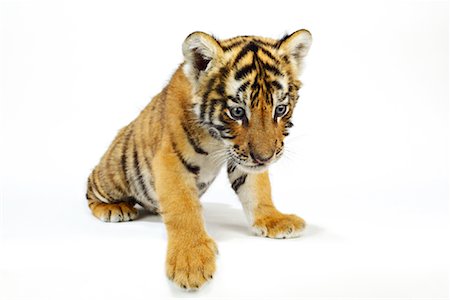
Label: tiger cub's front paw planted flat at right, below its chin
xmin=252 ymin=213 xmax=306 ymax=239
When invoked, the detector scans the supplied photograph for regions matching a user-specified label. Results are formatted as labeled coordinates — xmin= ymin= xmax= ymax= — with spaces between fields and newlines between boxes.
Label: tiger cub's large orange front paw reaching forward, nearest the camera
xmin=166 ymin=237 xmax=217 ymax=290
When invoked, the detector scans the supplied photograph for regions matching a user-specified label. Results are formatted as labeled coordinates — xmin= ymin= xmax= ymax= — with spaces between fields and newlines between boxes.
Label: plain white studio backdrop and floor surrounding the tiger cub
xmin=0 ymin=0 xmax=449 ymax=300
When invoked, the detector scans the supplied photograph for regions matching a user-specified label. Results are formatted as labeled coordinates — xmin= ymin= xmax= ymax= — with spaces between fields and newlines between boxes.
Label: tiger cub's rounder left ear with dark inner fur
xmin=183 ymin=31 xmax=223 ymax=81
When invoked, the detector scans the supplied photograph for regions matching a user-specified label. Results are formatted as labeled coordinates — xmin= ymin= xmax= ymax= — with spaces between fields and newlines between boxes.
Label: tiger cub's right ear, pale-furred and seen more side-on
xmin=280 ymin=29 xmax=312 ymax=73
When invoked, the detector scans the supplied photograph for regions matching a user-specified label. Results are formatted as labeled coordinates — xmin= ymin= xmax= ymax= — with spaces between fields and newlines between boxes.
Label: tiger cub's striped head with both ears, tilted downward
xmin=183 ymin=30 xmax=311 ymax=172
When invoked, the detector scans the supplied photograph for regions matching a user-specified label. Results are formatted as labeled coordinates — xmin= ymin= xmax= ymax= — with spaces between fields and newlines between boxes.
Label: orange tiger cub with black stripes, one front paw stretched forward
xmin=86 ymin=30 xmax=311 ymax=289
